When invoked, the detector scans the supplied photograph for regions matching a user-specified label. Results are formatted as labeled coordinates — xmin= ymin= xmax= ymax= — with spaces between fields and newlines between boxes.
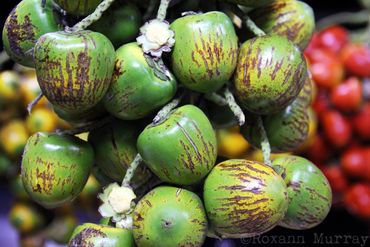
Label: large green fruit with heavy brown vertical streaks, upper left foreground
xmin=35 ymin=31 xmax=115 ymax=112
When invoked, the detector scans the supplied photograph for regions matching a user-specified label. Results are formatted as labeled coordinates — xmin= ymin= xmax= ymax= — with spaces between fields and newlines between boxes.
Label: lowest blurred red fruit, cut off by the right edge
xmin=344 ymin=183 xmax=370 ymax=219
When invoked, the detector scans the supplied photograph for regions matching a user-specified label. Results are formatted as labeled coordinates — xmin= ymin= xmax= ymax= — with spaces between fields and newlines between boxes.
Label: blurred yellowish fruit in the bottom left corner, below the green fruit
xmin=9 ymin=202 xmax=46 ymax=234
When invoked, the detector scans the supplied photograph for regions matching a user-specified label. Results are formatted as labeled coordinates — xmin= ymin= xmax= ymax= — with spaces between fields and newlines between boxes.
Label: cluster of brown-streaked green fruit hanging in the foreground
xmin=3 ymin=0 xmax=331 ymax=246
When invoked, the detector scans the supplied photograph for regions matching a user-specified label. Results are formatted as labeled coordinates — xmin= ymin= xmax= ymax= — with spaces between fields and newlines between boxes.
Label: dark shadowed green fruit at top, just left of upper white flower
xmin=90 ymin=1 xmax=141 ymax=48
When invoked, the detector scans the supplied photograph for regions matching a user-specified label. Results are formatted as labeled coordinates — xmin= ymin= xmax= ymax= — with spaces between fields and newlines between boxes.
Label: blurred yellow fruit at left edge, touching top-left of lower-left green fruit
xmin=0 ymin=119 xmax=29 ymax=158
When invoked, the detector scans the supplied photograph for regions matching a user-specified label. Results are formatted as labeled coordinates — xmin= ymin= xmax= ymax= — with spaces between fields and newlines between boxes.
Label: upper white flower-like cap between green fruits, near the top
xmin=136 ymin=19 xmax=175 ymax=57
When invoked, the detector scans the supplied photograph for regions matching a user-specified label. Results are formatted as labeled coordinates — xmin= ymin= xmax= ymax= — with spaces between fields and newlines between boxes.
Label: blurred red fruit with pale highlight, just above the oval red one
xmin=330 ymin=77 xmax=362 ymax=112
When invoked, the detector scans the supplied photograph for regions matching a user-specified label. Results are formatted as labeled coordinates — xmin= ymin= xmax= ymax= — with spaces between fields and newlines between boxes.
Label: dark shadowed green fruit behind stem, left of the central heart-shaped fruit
xmin=89 ymin=120 xmax=151 ymax=187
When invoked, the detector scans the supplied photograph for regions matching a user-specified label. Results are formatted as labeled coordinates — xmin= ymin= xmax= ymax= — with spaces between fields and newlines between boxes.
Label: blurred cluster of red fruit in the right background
xmin=305 ymin=26 xmax=370 ymax=218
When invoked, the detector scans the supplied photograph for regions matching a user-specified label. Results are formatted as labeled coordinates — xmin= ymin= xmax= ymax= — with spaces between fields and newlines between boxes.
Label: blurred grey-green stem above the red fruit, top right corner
xmin=316 ymin=10 xmax=369 ymax=31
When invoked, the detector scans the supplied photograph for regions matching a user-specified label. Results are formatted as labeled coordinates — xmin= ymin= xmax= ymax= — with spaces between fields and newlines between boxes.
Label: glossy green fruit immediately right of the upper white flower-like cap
xmin=171 ymin=11 xmax=238 ymax=93
